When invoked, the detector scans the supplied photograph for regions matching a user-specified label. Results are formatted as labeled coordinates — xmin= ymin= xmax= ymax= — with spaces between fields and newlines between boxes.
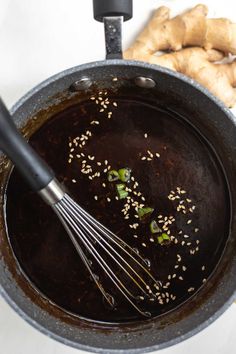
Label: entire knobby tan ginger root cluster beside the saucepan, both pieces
xmin=124 ymin=5 xmax=236 ymax=107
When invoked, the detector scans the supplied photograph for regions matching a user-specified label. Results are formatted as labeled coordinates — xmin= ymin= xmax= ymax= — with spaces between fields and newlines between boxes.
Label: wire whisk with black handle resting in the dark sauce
xmin=0 ymin=99 xmax=160 ymax=317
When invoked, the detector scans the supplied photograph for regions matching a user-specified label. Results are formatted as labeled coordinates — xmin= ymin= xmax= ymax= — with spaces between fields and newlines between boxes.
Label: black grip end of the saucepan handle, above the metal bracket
xmin=93 ymin=0 xmax=133 ymax=22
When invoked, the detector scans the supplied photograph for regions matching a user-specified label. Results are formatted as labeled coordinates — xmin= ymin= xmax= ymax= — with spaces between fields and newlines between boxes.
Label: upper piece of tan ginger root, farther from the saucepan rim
xmin=125 ymin=4 xmax=236 ymax=59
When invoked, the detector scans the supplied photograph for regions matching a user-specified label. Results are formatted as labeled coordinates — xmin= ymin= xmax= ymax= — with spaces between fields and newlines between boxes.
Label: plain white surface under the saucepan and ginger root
xmin=0 ymin=0 xmax=236 ymax=354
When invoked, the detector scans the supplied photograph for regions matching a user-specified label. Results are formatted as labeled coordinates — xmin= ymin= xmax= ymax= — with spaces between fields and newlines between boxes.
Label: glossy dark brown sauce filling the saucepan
xmin=6 ymin=97 xmax=229 ymax=322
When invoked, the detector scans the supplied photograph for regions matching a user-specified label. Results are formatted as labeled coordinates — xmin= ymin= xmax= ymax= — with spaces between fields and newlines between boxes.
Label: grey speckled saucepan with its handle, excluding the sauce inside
xmin=0 ymin=0 xmax=236 ymax=353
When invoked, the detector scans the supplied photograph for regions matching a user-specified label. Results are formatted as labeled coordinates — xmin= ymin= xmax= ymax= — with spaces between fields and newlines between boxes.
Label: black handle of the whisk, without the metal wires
xmin=0 ymin=98 xmax=54 ymax=191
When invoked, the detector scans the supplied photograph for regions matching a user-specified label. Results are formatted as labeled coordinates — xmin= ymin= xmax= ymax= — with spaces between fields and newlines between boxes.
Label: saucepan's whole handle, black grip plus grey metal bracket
xmin=93 ymin=0 xmax=133 ymax=59
